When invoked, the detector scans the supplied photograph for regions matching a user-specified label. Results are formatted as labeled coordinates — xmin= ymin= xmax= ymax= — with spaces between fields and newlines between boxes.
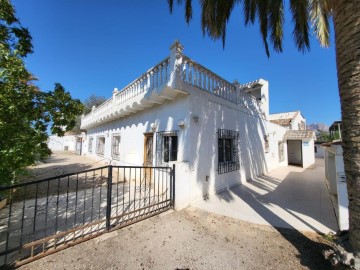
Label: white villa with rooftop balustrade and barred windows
xmin=81 ymin=42 xmax=314 ymax=209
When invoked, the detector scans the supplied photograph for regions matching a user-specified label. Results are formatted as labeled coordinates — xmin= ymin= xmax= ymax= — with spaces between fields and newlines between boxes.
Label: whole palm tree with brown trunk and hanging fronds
xmin=168 ymin=0 xmax=360 ymax=255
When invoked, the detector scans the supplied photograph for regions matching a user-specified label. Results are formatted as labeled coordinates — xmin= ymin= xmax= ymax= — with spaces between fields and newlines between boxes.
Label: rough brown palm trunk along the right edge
xmin=334 ymin=0 xmax=360 ymax=255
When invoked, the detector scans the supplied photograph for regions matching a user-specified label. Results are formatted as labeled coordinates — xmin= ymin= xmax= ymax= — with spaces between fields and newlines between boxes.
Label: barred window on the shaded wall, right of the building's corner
xmin=217 ymin=129 xmax=240 ymax=174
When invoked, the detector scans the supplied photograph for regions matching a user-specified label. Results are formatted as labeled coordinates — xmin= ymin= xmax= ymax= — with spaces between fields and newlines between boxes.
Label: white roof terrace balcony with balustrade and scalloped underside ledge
xmin=81 ymin=42 xmax=263 ymax=129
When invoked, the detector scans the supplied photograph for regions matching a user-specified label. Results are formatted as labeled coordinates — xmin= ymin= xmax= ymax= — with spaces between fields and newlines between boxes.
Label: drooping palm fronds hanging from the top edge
xmin=167 ymin=0 xmax=334 ymax=56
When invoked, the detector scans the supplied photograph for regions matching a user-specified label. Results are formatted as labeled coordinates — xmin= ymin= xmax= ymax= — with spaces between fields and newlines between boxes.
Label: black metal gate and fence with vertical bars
xmin=0 ymin=165 xmax=175 ymax=265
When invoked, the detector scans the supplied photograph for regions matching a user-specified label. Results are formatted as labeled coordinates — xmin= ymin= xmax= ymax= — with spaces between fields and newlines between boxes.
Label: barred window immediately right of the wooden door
xmin=156 ymin=130 xmax=178 ymax=165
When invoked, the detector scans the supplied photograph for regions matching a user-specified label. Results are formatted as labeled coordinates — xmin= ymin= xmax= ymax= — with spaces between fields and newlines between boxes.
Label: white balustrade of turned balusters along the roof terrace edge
xmin=82 ymin=46 xmax=260 ymax=130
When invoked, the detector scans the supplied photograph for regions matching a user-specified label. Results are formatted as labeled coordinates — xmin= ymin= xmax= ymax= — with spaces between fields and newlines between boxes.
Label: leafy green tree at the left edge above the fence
xmin=0 ymin=0 xmax=82 ymax=185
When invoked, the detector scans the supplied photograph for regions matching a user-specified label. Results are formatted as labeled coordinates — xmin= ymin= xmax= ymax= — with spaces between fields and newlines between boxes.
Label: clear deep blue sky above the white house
xmin=13 ymin=0 xmax=340 ymax=124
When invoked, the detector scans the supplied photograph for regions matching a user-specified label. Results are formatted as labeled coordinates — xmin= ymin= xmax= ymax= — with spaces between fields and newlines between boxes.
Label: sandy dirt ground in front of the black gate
xmin=20 ymin=208 xmax=331 ymax=270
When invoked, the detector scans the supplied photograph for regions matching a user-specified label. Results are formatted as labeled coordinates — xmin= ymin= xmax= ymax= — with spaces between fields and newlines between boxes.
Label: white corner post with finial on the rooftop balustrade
xmin=168 ymin=40 xmax=184 ymax=89
